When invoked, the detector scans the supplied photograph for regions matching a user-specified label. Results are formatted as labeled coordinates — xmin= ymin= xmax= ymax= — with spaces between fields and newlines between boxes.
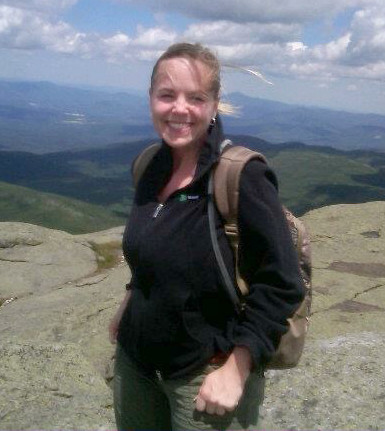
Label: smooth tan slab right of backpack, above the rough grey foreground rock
xmin=304 ymin=202 xmax=385 ymax=339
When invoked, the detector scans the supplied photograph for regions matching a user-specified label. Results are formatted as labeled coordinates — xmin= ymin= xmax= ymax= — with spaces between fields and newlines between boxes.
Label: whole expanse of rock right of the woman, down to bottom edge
xmin=261 ymin=202 xmax=385 ymax=430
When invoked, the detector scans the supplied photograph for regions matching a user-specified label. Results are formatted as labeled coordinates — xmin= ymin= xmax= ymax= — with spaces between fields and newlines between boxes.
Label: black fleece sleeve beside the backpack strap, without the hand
xmin=233 ymin=161 xmax=304 ymax=367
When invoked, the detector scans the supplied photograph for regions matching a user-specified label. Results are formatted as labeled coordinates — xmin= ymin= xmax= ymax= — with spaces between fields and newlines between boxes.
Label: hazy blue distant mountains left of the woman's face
xmin=0 ymin=80 xmax=154 ymax=153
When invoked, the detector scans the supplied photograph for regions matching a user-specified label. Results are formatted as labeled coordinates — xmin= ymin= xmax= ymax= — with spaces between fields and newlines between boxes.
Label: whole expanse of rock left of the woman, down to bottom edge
xmin=0 ymin=223 xmax=130 ymax=430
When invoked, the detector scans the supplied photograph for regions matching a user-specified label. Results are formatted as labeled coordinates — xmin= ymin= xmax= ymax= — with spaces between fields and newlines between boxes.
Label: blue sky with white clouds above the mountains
xmin=0 ymin=0 xmax=385 ymax=114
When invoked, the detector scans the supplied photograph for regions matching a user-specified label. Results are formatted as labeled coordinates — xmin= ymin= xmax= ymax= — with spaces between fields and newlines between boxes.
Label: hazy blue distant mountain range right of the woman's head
xmin=220 ymin=93 xmax=385 ymax=151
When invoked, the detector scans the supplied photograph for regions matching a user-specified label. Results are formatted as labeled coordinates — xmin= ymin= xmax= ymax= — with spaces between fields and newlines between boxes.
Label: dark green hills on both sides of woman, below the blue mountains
xmin=0 ymin=136 xmax=385 ymax=233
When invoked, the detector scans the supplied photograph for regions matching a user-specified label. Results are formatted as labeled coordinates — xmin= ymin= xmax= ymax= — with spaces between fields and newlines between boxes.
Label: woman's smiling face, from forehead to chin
xmin=150 ymin=57 xmax=218 ymax=149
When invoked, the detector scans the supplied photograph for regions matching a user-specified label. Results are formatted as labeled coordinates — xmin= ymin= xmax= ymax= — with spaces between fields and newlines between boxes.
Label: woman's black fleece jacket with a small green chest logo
xmin=118 ymin=117 xmax=304 ymax=378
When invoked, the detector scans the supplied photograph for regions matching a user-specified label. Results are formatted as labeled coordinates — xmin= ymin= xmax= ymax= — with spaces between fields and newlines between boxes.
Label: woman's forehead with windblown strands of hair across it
xmin=155 ymin=57 xmax=212 ymax=91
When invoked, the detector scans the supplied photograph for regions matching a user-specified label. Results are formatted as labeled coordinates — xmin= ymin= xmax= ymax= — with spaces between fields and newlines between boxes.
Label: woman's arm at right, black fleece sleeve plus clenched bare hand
xmin=196 ymin=161 xmax=304 ymax=415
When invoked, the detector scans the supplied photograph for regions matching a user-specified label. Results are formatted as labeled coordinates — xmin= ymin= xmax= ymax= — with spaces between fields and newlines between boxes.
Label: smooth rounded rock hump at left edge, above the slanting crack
xmin=0 ymin=222 xmax=97 ymax=298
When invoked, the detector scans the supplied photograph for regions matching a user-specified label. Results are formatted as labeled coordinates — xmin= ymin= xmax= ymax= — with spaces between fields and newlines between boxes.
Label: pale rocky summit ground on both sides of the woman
xmin=0 ymin=202 xmax=385 ymax=430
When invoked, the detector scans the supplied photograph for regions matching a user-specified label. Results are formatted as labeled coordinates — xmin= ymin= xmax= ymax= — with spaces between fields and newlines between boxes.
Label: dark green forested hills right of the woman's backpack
xmin=271 ymin=148 xmax=385 ymax=214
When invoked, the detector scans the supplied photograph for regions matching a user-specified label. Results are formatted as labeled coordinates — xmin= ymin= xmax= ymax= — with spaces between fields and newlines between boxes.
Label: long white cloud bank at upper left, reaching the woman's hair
xmin=0 ymin=0 xmax=177 ymax=62
